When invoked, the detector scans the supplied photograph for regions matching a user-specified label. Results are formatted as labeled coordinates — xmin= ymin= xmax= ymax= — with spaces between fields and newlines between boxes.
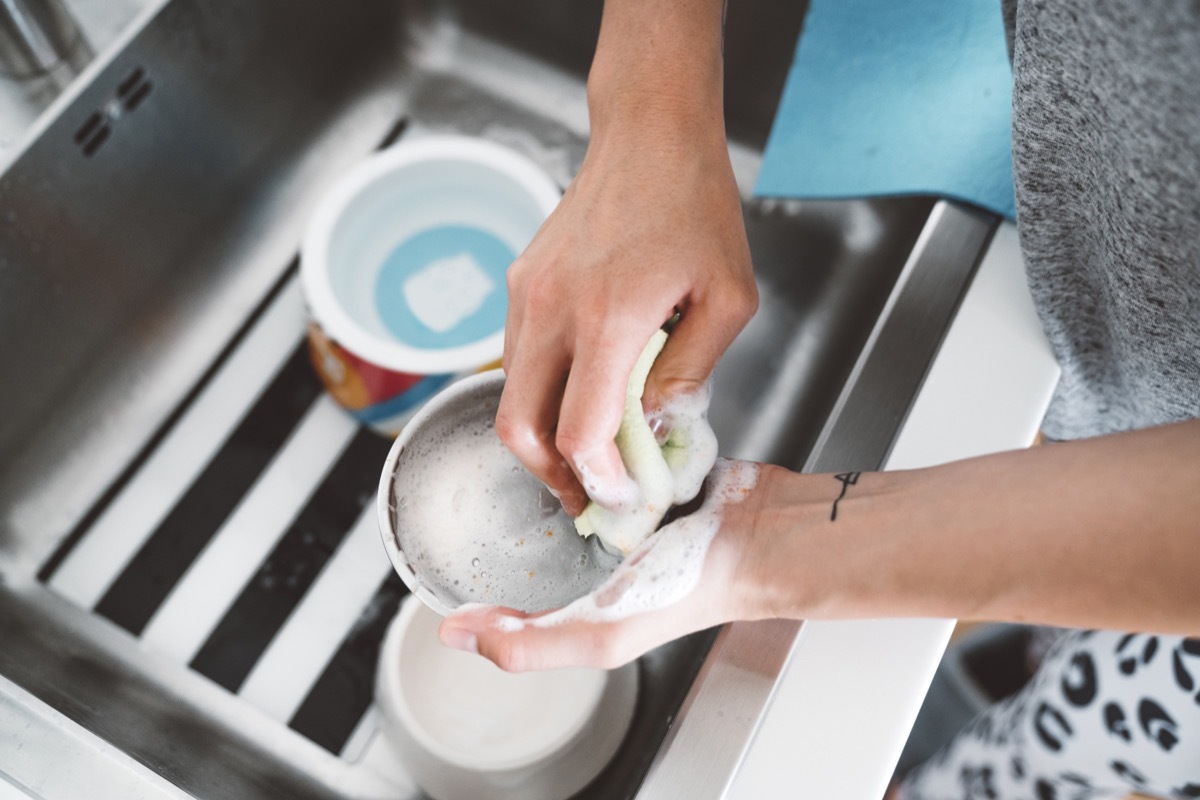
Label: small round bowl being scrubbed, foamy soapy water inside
xmin=377 ymin=369 xmax=620 ymax=615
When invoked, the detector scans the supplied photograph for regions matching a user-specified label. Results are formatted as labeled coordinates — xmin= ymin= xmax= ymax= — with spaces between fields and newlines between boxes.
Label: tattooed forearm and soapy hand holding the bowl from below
xmin=440 ymin=420 xmax=1200 ymax=669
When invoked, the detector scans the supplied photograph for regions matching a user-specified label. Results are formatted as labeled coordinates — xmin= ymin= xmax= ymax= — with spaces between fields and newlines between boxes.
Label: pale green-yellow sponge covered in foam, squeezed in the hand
xmin=575 ymin=330 xmax=716 ymax=555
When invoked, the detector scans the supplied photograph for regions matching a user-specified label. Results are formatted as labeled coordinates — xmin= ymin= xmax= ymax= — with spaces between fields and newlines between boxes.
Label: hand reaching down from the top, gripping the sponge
xmin=496 ymin=0 xmax=757 ymax=515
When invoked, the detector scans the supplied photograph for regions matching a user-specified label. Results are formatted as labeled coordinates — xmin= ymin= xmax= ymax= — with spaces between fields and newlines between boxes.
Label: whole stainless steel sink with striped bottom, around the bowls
xmin=0 ymin=0 xmax=991 ymax=798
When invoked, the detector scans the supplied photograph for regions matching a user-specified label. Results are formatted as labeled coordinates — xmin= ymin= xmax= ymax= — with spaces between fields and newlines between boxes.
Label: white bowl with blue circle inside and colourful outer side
xmin=300 ymin=136 xmax=560 ymax=434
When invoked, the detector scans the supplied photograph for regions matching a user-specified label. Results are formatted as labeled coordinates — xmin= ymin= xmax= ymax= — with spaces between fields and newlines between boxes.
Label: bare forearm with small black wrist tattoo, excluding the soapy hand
xmin=742 ymin=421 xmax=1200 ymax=633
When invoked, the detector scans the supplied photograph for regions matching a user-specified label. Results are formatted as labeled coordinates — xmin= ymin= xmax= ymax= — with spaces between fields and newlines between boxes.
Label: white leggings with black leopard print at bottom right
xmin=900 ymin=631 xmax=1200 ymax=800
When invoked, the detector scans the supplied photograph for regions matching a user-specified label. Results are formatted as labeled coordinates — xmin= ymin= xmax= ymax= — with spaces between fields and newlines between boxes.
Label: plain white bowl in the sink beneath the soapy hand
xmin=376 ymin=596 xmax=637 ymax=800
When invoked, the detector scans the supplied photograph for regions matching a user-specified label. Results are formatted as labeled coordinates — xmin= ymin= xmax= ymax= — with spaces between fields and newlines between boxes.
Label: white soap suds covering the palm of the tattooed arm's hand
xmin=496 ymin=459 xmax=758 ymax=632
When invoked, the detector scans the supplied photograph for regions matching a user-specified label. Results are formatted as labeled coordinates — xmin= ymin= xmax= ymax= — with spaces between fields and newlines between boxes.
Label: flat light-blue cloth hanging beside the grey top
xmin=755 ymin=0 xmax=1015 ymax=218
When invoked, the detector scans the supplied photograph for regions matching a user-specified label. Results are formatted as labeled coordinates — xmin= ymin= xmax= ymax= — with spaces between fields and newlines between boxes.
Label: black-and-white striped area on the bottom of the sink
xmin=38 ymin=264 xmax=407 ymax=762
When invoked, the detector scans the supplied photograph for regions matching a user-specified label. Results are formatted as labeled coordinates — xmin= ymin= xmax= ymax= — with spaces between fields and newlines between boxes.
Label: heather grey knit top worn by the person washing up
xmin=1004 ymin=0 xmax=1200 ymax=439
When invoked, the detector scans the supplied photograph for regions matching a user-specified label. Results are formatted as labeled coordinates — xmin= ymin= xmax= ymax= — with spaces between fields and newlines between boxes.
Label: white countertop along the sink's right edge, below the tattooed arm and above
xmin=728 ymin=223 xmax=1058 ymax=800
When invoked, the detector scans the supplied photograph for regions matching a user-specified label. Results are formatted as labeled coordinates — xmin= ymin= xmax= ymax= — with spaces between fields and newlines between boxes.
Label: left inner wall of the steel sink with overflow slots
xmin=0 ymin=0 xmax=417 ymax=561
